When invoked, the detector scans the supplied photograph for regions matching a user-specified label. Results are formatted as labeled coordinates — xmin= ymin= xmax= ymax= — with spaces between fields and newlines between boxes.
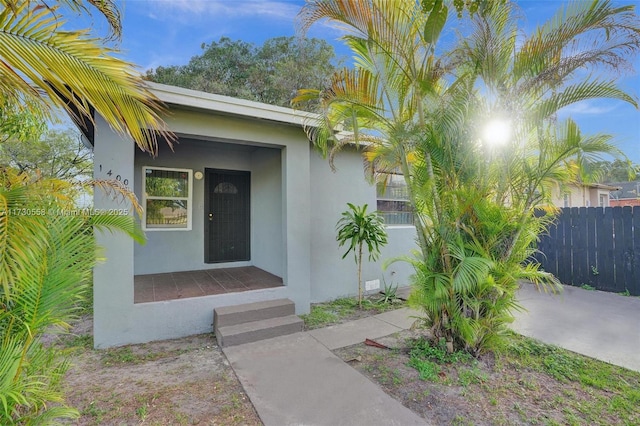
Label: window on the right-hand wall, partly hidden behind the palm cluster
xmin=376 ymin=173 xmax=414 ymax=225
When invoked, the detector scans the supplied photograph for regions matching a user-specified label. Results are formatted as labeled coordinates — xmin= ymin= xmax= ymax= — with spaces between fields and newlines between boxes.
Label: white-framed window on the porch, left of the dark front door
xmin=142 ymin=166 xmax=193 ymax=231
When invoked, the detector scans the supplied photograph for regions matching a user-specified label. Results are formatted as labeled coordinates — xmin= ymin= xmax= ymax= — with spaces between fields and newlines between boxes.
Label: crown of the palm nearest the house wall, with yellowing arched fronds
xmin=294 ymin=0 xmax=448 ymax=260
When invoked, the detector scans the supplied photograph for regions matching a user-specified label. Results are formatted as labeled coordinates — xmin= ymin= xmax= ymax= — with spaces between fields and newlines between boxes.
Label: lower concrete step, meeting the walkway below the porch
xmin=216 ymin=315 xmax=304 ymax=347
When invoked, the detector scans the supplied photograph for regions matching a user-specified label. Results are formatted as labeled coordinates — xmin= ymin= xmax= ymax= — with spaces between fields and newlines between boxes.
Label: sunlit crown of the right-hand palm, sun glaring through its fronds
xmin=458 ymin=0 xmax=640 ymax=240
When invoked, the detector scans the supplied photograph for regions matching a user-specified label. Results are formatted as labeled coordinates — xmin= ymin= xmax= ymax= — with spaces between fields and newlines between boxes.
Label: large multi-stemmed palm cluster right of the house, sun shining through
xmin=300 ymin=0 xmax=640 ymax=353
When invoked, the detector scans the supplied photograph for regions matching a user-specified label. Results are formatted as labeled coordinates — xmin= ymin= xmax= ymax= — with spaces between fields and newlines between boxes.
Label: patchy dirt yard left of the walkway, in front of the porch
xmin=56 ymin=319 xmax=262 ymax=425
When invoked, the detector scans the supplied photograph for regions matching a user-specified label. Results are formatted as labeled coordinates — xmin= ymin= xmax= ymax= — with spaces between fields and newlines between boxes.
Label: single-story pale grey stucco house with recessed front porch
xmin=91 ymin=84 xmax=415 ymax=348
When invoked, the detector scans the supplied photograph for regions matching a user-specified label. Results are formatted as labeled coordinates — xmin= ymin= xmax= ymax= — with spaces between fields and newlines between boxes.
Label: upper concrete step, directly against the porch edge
xmin=213 ymin=299 xmax=296 ymax=330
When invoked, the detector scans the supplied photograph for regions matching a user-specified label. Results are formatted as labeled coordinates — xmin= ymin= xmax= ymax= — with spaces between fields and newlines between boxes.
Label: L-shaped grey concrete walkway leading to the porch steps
xmin=223 ymin=309 xmax=430 ymax=426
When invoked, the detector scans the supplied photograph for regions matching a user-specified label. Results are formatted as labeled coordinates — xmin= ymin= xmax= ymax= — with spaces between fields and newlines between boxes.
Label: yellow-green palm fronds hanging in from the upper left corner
xmin=0 ymin=0 xmax=171 ymax=153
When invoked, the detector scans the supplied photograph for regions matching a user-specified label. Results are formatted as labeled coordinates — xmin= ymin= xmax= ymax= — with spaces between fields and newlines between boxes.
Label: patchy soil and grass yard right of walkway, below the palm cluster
xmin=335 ymin=331 xmax=640 ymax=425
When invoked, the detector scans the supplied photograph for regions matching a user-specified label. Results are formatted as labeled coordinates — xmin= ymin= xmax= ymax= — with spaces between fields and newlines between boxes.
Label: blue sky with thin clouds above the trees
xmin=80 ymin=0 xmax=640 ymax=163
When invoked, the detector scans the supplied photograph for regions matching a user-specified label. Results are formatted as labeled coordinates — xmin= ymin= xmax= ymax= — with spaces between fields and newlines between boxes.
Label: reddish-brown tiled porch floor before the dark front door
xmin=133 ymin=266 xmax=283 ymax=303
